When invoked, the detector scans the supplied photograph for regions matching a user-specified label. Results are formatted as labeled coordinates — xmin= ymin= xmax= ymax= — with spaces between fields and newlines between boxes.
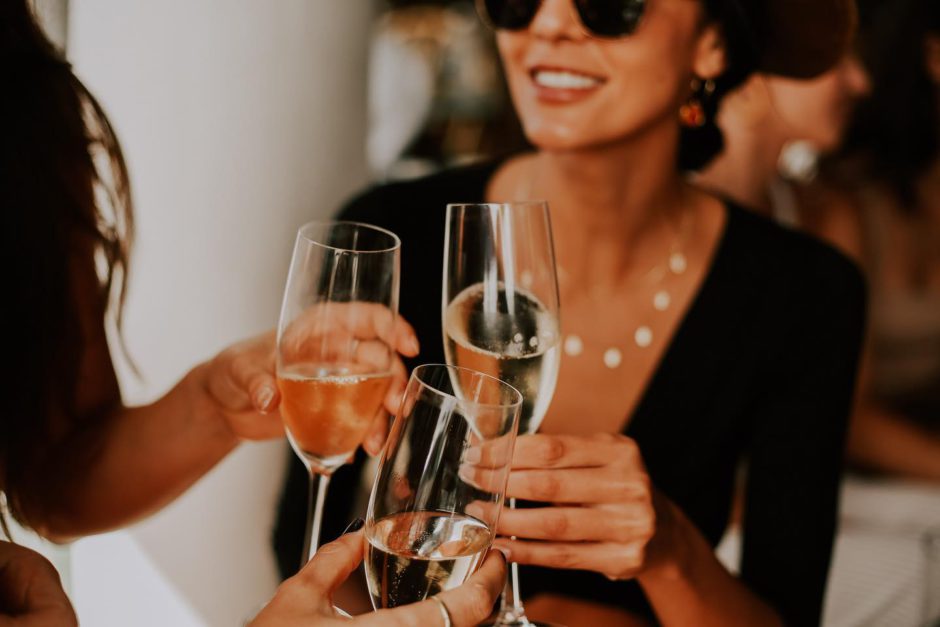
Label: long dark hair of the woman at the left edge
xmin=0 ymin=0 xmax=133 ymax=535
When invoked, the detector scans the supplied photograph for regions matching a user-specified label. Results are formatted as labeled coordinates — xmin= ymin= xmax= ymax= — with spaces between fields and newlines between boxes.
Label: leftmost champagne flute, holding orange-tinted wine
xmin=277 ymin=222 xmax=401 ymax=563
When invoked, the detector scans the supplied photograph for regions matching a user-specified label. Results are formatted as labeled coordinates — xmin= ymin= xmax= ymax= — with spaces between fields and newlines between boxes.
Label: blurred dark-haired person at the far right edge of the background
xmin=801 ymin=0 xmax=940 ymax=627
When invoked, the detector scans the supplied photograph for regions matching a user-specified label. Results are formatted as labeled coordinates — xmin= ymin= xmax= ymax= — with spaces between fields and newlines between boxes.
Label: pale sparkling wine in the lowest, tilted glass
xmin=365 ymin=512 xmax=493 ymax=609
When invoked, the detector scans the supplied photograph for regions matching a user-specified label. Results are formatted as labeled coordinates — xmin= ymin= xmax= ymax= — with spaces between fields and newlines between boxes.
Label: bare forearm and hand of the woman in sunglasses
xmin=492 ymin=434 xmax=780 ymax=627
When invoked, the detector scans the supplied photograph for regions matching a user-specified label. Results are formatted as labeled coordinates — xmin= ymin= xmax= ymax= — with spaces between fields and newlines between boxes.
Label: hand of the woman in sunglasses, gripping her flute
xmin=496 ymin=434 xmax=672 ymax=579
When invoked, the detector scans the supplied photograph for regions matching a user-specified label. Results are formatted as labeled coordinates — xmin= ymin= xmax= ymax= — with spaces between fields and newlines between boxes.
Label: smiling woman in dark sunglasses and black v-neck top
xmin=282 ymin=0 xmax=864 ymax=626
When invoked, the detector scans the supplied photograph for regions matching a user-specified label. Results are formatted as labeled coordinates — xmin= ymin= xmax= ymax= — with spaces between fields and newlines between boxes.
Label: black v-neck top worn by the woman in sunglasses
xmin=275 ymin=163 xmax=865 ymax=625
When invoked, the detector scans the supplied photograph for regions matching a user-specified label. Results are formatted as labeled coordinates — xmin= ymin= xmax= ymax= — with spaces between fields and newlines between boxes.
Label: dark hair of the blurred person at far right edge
xmin=837 ymin=0 xmax=940 ymax=210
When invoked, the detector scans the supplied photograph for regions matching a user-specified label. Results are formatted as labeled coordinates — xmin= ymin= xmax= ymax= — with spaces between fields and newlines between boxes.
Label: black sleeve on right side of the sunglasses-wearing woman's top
xmin=741 ymin=253 xmax=865 ymax=626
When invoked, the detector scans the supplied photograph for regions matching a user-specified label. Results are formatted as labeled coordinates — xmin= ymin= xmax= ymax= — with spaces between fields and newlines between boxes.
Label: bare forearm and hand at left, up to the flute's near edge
xmin=21 ymin=334 xmax=282 ymax=541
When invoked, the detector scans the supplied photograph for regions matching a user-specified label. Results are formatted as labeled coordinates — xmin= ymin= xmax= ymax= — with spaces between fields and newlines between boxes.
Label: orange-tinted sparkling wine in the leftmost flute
xmin=277 ymin=364 xmax=392 ymax=469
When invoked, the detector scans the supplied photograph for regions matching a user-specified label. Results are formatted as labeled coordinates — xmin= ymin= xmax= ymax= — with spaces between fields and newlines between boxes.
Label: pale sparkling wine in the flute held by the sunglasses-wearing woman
xmin=444 ymin=284 xmax=559 ymax=433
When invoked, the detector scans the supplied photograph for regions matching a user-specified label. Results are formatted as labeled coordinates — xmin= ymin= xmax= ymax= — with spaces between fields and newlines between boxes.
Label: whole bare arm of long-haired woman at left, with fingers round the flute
xmin=16 ymin=238 xmax=417 ymax=541
